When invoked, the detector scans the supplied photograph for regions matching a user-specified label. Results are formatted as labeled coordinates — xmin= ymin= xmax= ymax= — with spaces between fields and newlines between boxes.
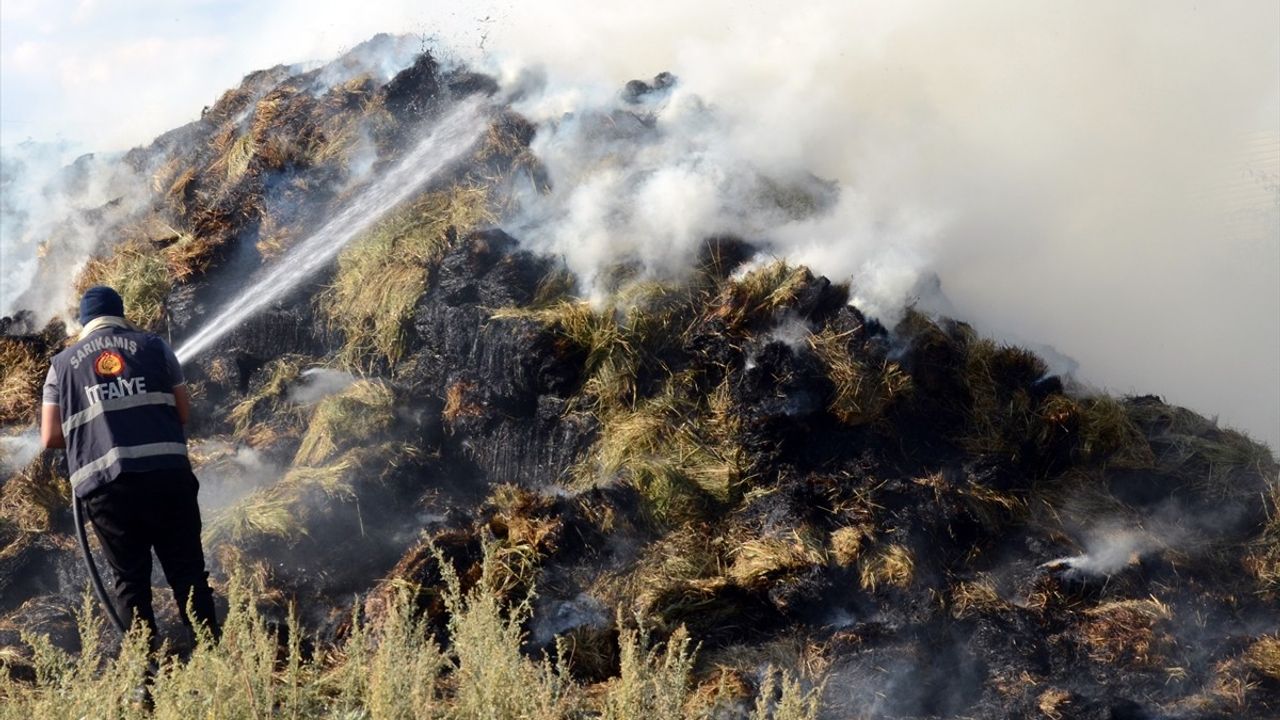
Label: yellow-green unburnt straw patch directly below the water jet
xmin=319 ymin=187 xmax=493 ymax=368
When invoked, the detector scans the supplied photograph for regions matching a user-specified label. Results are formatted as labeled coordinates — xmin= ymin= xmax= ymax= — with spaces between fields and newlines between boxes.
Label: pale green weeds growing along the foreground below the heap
xmin=0 ymin=538 xmax=822 ymax=720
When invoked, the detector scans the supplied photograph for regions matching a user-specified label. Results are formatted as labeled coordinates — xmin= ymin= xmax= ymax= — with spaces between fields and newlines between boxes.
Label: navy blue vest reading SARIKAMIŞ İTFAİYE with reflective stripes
xmin=52 ymin=327 xmax=191 ymax=497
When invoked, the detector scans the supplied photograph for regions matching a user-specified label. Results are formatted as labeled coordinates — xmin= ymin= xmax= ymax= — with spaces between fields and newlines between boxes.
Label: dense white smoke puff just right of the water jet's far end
xmin=499 ymin=79 xmax=785 ymax=295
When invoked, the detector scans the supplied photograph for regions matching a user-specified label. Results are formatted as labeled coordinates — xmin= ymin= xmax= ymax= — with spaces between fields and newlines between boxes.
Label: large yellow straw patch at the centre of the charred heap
xmin=494 ymin=265 xmax=773 ymax=523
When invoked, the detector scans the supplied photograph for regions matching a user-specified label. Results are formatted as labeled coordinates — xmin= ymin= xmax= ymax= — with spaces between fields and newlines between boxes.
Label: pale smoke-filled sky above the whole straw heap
xmin=0 ymin=0 xmax=1280 ymax=447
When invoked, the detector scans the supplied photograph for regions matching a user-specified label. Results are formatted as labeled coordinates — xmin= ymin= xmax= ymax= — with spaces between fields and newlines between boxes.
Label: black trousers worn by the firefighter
xmin=82 ymin=469 xmax=219 ymax=638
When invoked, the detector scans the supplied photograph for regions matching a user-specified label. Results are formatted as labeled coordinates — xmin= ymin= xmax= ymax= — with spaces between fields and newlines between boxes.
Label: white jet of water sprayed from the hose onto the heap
xmin=175 ymin=100 xmax=484 ymax=363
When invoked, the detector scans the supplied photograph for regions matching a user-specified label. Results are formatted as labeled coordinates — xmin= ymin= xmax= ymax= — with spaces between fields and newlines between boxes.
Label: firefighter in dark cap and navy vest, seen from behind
xmin=40 ymin=286 xmax=219 ymax=647
